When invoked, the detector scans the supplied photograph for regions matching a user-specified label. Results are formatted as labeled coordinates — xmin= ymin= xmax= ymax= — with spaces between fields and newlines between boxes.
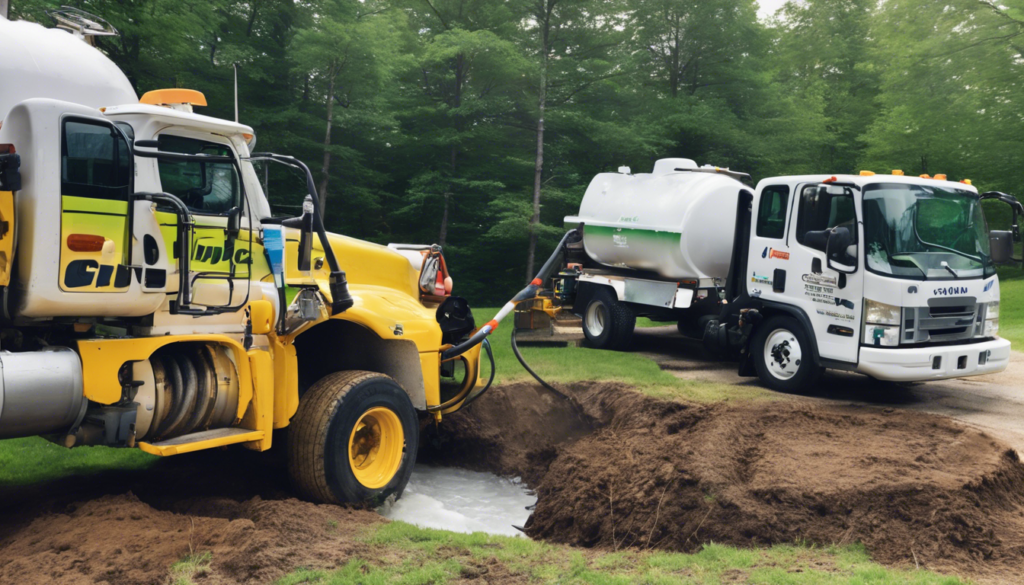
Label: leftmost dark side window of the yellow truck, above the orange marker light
xmin=60 ymin=119 xmax=132 ymax=201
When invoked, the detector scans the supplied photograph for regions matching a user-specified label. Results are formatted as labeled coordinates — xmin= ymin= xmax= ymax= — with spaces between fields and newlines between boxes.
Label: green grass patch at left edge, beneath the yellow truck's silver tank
xmin=0 ymin=436 xmax=160 ymax=487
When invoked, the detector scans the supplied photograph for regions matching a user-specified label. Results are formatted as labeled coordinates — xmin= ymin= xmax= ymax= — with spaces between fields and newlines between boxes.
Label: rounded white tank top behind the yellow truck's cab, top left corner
xmin=0 ymin=18 xmax=138 ymax=120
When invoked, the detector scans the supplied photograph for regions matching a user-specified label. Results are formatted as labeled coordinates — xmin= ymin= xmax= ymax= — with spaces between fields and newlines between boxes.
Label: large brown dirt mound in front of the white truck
xmin=427 ymin=384 xmax=1024 ymax=575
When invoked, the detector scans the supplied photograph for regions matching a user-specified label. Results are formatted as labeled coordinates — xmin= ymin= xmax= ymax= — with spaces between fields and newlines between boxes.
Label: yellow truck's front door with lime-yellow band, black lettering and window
xmin=158 ymin=129 xmax=249 ymax=307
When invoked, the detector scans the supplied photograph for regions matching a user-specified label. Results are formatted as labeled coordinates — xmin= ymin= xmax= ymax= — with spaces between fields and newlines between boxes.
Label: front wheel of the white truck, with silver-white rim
xmin=750 ymin=317 xmax=824 ymax=392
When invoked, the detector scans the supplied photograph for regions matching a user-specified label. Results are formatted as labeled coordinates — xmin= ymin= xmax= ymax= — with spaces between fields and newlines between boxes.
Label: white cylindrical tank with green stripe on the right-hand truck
xmin=565 ymin=159 xmax=746 ymax=279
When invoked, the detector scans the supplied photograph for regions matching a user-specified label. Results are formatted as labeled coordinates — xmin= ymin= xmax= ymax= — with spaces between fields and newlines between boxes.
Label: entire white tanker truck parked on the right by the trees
xmin=555 ymin=159 xmax=1024 ymax=390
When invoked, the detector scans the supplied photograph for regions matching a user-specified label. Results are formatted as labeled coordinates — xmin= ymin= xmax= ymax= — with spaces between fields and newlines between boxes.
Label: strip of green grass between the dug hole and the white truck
xmin=473 ymin=308 xmax=772 ymax=402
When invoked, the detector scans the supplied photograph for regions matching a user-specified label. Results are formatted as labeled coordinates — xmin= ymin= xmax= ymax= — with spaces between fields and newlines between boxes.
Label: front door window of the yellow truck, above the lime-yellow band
xmin=159 ymin=134 xmax=240 ymax=214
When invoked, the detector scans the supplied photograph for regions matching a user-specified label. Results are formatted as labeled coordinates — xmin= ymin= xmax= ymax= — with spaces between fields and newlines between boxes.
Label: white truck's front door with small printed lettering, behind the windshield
xmin=785 ymin=183 xmax=864 ymax=363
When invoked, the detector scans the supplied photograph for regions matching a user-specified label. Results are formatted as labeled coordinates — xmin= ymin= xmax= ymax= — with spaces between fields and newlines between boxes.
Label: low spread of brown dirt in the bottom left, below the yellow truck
xmin=0 ymin=493 xmax=383 ymax=585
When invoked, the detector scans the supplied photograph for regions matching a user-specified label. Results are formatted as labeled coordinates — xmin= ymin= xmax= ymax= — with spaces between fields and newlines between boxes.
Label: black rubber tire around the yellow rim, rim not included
xmin=288 ymin=371 xmax=419 ymax=504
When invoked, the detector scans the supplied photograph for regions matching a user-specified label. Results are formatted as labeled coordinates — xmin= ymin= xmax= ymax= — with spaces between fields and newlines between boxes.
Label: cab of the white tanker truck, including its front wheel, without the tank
xmin=742 ymin=172 xmax=1020 ymax=388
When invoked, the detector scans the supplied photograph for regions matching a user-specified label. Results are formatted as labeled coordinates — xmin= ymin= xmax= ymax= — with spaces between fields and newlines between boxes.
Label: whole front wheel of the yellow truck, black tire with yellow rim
xmin=288 ymin=371 xmax=419 ymax=504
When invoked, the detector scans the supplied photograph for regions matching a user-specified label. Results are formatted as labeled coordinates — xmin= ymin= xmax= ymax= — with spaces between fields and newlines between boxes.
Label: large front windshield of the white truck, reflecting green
xmin=864 ymin=183 xmax=995 ymax=280
